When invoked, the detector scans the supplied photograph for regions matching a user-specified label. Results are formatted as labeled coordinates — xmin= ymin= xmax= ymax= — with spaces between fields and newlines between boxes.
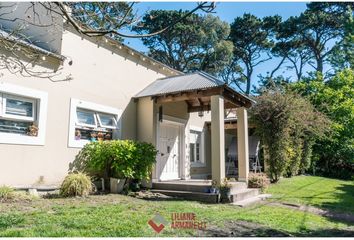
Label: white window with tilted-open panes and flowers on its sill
xmin=69 ymin=99 xmax=122 ymax=147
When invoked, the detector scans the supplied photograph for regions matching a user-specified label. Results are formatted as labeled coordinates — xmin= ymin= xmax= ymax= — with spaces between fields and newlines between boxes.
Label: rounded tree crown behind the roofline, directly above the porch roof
xmin=133 ymin=10 xmax=233 ymax=74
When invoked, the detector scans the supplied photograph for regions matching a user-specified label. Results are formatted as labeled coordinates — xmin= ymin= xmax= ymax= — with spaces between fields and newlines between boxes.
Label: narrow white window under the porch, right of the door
xmin=189 ymin=127 xmax=205 ymax=167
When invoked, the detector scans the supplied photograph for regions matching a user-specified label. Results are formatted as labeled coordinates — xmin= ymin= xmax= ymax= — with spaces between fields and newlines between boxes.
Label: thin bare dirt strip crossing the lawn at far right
xmin=268 ymin=202 xmax=354 ymax=223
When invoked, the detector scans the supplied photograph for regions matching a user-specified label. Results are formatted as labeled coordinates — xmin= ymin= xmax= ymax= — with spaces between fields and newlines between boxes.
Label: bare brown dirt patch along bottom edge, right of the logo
xmin=199 ymin=221 xmax=291 ymax=237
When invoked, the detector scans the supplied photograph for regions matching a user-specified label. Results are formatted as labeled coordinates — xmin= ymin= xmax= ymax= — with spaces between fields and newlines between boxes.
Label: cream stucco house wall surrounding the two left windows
xmin=0 ymin=28 xmax=171 ymax=185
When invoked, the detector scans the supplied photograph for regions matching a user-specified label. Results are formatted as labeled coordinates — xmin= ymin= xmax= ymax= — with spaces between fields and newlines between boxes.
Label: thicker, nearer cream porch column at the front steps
xmin=211 ymin=95 xmax=225 ymax=184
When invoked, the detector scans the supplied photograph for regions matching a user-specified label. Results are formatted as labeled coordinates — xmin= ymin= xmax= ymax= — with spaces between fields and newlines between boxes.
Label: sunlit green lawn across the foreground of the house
xmin=0 ymin=177 xmax=354 ymax=237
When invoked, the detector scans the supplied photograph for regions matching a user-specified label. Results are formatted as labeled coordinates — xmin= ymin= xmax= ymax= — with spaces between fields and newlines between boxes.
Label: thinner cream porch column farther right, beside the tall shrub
xmin=236 ymin=107 xmax=249 ymax=182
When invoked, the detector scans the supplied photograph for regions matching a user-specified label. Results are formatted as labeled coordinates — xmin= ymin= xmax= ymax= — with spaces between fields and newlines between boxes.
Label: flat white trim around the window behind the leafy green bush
xmin=68 ymin=98 xmax=123 ymax=148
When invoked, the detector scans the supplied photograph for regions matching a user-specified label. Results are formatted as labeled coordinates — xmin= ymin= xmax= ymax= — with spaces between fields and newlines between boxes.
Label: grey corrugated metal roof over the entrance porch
xmin=134 ymin=72 xmax=225 ymax=98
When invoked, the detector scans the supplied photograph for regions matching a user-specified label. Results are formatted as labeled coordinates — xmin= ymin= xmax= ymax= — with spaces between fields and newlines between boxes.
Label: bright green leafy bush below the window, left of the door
xmin=70 ymin=140 xmax=157 ymax=180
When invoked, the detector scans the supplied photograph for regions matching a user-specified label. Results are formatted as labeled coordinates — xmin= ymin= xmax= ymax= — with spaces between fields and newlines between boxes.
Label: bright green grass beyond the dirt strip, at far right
xmin=267 ymin=176 xmax=354 ymax=214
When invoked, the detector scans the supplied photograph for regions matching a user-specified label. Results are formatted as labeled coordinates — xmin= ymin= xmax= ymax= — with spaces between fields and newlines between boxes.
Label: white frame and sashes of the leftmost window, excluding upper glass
xmin=0 ymin=82 xmax=48 ymax=145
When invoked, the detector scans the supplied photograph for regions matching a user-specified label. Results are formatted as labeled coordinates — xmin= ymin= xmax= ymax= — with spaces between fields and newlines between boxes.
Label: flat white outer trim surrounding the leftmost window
xmin=0 ymin=82 xmax=48 ymax=145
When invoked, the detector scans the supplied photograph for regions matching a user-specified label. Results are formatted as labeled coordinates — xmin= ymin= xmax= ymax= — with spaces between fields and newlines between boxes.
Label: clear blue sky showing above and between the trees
xmin=124 ymin=1 xmax=307 ymax=91
